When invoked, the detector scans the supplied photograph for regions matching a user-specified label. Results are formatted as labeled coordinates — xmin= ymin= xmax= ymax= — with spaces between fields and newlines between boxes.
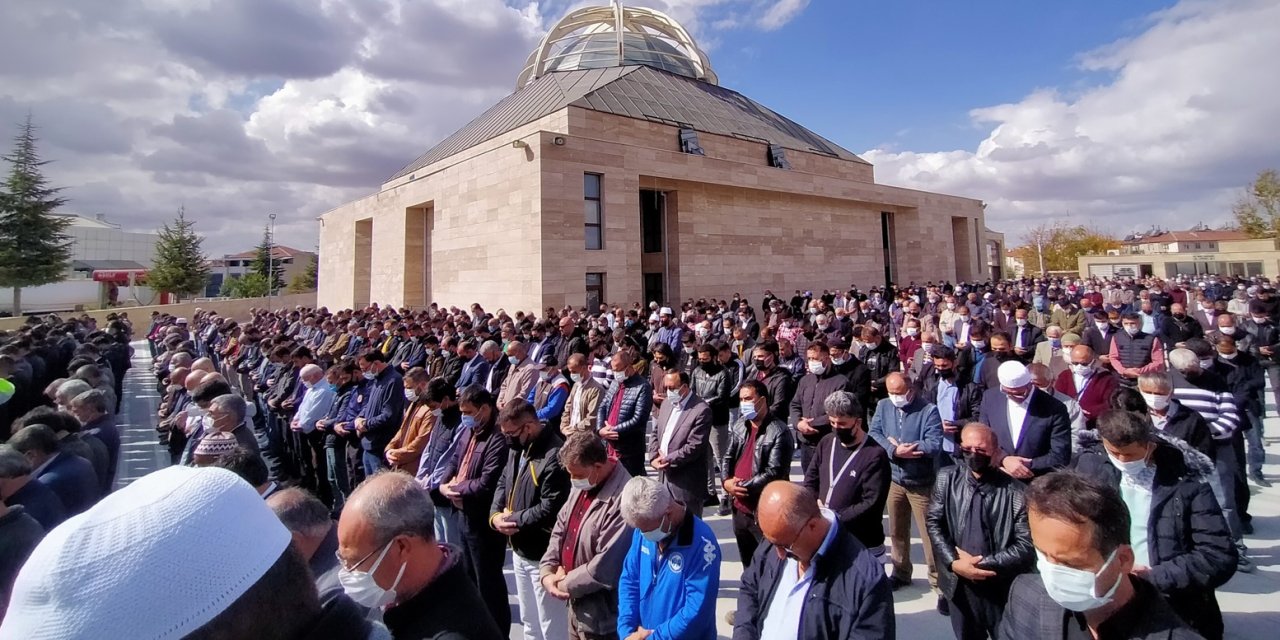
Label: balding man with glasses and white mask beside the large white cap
xmin=338 ymin=471 xmax=509 ymax=640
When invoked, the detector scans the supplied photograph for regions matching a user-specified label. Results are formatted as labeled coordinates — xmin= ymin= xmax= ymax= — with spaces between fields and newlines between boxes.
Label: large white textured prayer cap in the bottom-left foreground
xmin=0 ymin=467 xmax=292 ymax=640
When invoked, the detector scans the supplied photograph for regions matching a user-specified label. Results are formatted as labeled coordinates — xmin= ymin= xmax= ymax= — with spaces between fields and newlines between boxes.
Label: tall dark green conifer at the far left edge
xmin=0 ymin=115 xmax=72 ymax=315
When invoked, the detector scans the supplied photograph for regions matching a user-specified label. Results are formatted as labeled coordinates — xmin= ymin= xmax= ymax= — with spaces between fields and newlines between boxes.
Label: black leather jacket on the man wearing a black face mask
xmin=925 ymin=466 xmax=1036 ymax=598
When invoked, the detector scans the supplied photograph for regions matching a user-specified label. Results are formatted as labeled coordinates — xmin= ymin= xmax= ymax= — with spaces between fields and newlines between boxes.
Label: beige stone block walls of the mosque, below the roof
xmin=319 ymin=106 xmax=987 ymax=312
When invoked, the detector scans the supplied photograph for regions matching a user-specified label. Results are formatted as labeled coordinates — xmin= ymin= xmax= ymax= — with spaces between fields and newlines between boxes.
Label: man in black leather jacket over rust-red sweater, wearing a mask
xmin=721 ymin=380 xmax=793 ymax=566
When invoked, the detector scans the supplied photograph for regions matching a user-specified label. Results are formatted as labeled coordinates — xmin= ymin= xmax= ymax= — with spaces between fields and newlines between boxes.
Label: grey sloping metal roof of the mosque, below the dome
xmin=389 ymin=67 xmax=865 ymax=180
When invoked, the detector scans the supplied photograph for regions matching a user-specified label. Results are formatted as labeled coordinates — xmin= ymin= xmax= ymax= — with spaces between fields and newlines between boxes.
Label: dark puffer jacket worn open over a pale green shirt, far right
xmin=1075 ymin=431 xmax=1236 ymax=639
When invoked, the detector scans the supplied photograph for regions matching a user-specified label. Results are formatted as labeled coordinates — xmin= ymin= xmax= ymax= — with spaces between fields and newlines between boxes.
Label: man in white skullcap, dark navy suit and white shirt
xmin=975 ymin=361 xmax=1071 ymax=480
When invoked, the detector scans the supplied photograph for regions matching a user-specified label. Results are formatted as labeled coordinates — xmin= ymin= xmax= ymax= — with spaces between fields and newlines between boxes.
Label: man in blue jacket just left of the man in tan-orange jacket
xmin=355 ymin=349 xmax=404 ymax=476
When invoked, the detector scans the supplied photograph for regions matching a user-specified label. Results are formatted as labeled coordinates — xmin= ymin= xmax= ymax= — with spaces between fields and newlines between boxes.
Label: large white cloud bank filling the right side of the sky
xmin=863 ymin=0 xmax=1280 ymax=243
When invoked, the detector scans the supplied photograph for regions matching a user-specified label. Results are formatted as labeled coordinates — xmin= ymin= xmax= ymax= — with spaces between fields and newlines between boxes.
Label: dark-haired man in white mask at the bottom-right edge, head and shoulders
xmin=998 ymin=471 xmax=1201 ymax=640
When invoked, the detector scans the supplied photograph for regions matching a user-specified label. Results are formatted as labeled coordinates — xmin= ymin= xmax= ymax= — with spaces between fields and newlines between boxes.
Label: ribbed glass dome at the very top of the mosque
xmin=516 ymin=3 xmax=717 ymax=88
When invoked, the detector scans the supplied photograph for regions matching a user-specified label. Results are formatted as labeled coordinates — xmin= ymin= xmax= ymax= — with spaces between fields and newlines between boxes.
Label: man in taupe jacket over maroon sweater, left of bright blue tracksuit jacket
xmin=539 ymin=431 xmax=631 ymax=640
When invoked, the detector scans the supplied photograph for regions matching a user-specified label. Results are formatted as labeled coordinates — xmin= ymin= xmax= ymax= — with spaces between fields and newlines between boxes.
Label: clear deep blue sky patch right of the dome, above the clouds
xmin=709 ymin=0 xmax=1174 ymax=152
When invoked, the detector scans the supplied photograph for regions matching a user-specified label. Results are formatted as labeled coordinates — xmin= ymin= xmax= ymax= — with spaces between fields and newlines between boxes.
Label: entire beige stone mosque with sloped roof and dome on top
xmin=319 ymin=4 xmax=983 ymax=312
